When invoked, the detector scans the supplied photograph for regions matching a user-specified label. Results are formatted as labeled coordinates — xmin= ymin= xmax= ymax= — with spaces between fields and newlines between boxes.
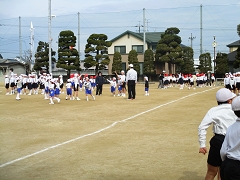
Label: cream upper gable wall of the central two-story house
xmin=108 ymin=34 xmax=147 ymax=54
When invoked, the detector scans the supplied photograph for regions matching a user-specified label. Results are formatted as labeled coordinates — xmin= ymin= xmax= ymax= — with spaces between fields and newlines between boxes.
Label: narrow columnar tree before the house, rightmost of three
xmin=143 ymin=49 xmax=156 ymax=77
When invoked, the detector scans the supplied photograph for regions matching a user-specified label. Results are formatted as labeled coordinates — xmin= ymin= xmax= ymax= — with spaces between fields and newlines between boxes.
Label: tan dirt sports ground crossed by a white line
xmin=0 ymin=83 xmax=220 ymax=180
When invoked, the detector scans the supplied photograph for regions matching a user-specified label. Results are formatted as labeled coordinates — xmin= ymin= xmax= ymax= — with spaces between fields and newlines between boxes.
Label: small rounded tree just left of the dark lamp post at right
xmin=198 ymin=53 xmax=212 ymax=73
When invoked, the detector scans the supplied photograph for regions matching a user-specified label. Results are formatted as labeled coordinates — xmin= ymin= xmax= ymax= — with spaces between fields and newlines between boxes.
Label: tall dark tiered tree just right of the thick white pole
xmin=57 ymin=30 xmax=81 ymax=78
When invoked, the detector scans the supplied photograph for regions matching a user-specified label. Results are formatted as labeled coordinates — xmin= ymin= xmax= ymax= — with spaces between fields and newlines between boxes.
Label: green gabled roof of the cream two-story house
xmin=111 ymin=31 xmax=163 ymax=43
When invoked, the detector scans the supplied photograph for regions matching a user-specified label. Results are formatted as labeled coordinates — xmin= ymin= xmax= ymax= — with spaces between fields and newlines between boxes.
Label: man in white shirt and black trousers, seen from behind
xmin=126 ymin=64 xmax=137 ymax=100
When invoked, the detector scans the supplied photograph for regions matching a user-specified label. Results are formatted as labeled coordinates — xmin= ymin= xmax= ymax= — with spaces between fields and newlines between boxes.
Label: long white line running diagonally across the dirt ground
xmin=0 ymin=88 xmax=218 ymax=168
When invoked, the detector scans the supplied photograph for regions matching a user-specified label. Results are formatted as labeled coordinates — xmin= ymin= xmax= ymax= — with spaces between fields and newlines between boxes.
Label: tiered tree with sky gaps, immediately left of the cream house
xmin=84 ymin=34 xmax=112 ymax=74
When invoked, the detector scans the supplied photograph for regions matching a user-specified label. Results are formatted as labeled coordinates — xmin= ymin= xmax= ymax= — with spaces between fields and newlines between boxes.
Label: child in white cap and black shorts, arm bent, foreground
xmin=198 ymin=88 xmax=237 ymax=180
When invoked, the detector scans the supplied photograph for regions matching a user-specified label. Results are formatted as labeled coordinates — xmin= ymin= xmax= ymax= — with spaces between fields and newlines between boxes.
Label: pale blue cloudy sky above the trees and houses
xmin=0 ymin=0 xmax=240 ymax=61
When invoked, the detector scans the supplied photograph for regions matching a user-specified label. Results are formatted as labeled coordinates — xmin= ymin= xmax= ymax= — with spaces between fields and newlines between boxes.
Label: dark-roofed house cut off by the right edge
xmin=227 ymin=40 xmax=240 ymax=72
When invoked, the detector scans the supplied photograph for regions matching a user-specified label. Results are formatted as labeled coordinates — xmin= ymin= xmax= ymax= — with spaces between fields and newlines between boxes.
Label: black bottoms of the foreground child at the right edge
xmin=220 ymin=158 xmax=240 ymax=180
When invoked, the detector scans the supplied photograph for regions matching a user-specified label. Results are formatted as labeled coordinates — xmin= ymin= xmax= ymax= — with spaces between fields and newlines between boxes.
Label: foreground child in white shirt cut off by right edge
xmin=220 ymin=96 xmax=240 ymax=180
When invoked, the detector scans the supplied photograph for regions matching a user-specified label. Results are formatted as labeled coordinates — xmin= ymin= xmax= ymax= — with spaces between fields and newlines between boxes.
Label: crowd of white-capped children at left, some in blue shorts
xmin=5 ymin=70 xmax=95 ymax=104
